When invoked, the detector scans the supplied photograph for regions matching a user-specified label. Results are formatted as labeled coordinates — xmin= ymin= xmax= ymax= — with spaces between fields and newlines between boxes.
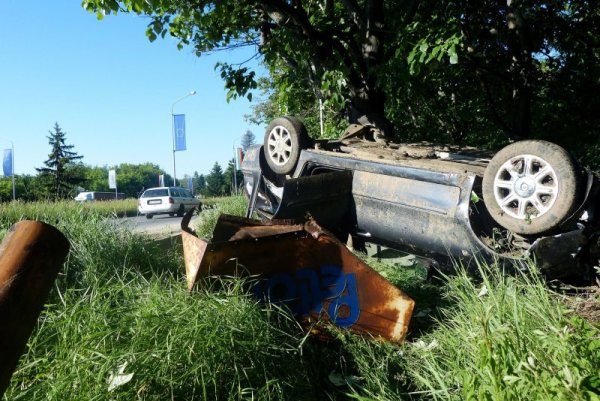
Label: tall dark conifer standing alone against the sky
xmin=36 ymin=123 xmax=85 ymax=199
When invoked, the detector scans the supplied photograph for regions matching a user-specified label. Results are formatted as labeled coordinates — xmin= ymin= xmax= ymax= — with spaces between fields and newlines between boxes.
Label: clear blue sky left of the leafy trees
xmin=0 ymin=0 xmax=264 ymax=178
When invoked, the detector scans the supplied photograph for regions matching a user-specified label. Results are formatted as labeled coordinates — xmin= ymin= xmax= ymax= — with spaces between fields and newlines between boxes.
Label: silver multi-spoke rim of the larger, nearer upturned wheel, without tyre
xmin=494 ymin=155 xmax=558 ymax=220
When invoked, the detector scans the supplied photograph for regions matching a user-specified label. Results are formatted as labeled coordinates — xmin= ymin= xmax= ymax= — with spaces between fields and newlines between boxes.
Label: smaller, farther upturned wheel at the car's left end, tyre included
xmin=263 ymin=117 xmax=310 ymax=174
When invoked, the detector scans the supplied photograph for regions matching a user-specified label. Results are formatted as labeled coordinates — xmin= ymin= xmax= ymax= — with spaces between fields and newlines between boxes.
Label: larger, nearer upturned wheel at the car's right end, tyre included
xmin=483 ymin=140 xmax=581 ymax=235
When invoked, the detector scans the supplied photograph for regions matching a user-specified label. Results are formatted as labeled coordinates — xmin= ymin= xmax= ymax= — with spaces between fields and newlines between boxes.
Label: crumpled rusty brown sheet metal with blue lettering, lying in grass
xmin=181 ymin=209 xmax=414 ymax=342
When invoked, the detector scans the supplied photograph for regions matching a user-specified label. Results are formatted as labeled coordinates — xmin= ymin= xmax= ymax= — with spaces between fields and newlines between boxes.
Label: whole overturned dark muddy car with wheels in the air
xmin=242 ymin=117 xmax=600 ymax=277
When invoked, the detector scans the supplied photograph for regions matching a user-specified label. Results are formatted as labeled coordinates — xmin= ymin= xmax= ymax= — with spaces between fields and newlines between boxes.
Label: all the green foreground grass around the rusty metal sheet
xmin=0 ymin=197 xmax=600 ymax=401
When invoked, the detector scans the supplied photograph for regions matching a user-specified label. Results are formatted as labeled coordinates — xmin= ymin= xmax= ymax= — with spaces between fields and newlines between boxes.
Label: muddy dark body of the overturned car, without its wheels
xmin=242 ymin=141 xmax=600 ymax=277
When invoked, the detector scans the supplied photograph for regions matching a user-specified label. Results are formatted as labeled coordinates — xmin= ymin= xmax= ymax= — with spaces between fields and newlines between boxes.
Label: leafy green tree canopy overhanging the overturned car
xmin=82 ymin=0 xmax=600 ymax=168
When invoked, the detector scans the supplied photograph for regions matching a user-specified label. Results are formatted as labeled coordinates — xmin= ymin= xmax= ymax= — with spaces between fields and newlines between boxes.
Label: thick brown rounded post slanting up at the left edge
xmin=0 ymin=221 xmax=69 ymax=397
